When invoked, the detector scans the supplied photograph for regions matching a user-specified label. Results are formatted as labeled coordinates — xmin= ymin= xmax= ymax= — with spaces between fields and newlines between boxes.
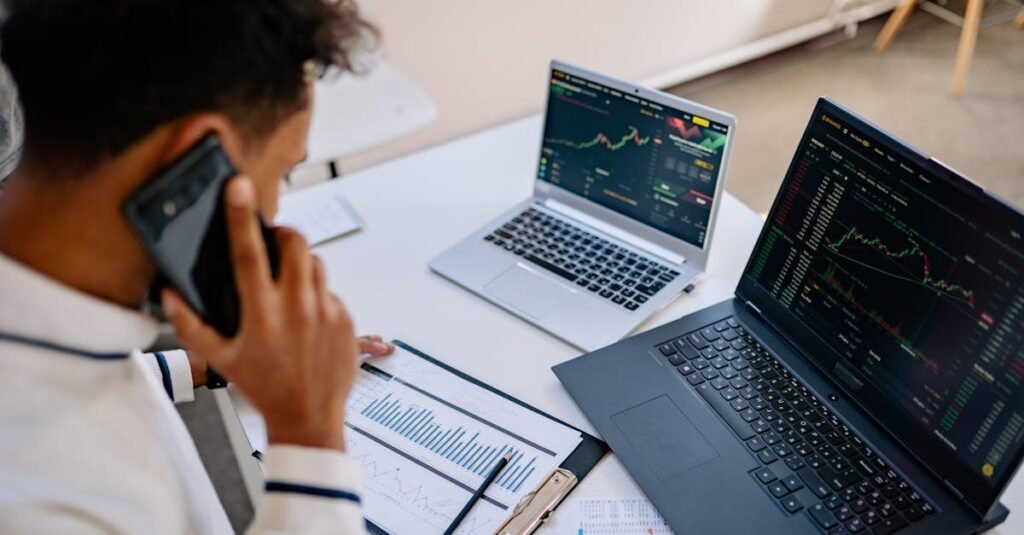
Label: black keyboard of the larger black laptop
xmin=658 ymin=318 xmax=935 ymax=534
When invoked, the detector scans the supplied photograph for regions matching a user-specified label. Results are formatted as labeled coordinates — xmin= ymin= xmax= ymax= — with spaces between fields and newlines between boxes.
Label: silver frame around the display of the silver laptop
xmin=534 ymin=59 xmax=736 ymax=271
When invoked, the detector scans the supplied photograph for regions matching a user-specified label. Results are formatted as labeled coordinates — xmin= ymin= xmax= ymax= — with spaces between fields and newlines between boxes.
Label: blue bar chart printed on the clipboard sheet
xmin=359 ymin=392 xmax=538 ymax=493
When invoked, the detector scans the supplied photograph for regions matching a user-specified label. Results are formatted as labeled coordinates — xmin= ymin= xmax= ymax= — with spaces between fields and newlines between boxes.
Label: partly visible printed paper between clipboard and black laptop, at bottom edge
xmin=552 ymin=496 xmax=672 ymax=535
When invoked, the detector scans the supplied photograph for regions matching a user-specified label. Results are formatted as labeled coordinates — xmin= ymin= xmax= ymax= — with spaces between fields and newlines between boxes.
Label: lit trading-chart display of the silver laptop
xmin=538 ymin=70 xmax=730 ymax=247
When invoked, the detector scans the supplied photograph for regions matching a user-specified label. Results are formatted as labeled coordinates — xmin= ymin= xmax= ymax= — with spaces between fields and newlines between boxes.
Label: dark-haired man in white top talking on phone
xmin=0 ymin=0 xmax=387 ymax=533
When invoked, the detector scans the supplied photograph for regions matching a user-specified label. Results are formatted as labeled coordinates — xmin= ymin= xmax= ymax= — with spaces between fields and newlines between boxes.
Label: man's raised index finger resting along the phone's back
xmin=225 ymin=176 xmax=271 ymax=305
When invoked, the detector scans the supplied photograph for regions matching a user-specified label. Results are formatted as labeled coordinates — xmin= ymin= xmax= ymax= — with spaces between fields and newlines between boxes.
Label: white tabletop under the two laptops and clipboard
xmin=218 ymin=116 xmax=1024 ymax=534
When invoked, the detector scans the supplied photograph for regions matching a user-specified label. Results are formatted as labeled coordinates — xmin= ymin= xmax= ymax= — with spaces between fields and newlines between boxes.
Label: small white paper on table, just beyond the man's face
xmin=274 ymin=188 xmax=362 ymax=246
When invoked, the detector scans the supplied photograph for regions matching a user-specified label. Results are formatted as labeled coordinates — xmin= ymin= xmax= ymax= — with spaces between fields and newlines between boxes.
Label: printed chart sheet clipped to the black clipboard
xmin=232 ymin=346 xmax=583 ymax=535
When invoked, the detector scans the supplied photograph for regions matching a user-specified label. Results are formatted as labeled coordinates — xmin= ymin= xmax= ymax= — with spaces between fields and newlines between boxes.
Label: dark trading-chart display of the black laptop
xmin=741 ymin=100 xmax=1024 ymax=508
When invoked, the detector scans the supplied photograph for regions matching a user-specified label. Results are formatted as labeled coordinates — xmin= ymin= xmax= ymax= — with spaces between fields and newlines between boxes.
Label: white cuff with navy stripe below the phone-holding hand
xmin=248 ymin=445 xmax=366 ymax=535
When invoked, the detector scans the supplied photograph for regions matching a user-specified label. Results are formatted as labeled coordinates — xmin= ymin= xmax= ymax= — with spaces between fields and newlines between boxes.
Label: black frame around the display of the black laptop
xmin=736 ymin=97 xmax=1024 ymax=517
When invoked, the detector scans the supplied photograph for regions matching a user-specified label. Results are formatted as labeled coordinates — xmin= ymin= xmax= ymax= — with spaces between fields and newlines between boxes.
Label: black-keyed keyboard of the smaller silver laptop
xmin=483 ymin=208 xmax=679 ymax=311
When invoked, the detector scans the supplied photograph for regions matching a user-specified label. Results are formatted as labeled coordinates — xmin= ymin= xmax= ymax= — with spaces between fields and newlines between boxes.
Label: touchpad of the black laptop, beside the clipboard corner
xmin=611 ymin=396 xmax=718 ymax=481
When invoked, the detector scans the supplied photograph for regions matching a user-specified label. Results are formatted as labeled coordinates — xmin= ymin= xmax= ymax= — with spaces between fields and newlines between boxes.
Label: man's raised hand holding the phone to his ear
xmin=163 ymin=177 xmax=359 ymax=450
